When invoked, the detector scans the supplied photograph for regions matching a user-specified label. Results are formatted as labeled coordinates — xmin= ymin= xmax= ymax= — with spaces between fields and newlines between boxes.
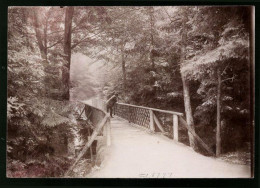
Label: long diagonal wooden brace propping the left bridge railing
xmin=64 ymin=115 xmax=109 ymax=177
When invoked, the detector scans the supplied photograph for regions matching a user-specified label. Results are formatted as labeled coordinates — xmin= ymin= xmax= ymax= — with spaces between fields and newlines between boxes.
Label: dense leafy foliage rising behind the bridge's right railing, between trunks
xmin=97 ymin=6 xmax=250 ymax=155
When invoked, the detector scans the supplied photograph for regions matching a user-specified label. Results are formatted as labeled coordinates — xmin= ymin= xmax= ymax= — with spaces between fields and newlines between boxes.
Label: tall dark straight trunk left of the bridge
xmin=62 ymin=7 xmax=74 ymax=100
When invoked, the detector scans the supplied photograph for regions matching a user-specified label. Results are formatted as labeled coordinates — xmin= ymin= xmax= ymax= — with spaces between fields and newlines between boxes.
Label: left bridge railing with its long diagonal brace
xmin=65 ymin=102 xmax=111 ymax=176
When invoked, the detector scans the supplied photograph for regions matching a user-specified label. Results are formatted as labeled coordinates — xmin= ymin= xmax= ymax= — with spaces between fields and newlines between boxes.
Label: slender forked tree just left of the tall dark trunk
xmin=27 ymin=7 xmax=64 ymax=100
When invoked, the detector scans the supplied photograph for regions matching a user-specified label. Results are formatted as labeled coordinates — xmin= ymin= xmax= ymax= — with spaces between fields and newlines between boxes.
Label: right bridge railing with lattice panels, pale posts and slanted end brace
xmin=92 ymin=99 xmax=215 ymax=155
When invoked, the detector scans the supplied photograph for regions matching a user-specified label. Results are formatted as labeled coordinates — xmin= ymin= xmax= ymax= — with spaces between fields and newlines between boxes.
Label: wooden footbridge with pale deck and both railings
xmin=65 ymin=99 xmax=251 ymax=178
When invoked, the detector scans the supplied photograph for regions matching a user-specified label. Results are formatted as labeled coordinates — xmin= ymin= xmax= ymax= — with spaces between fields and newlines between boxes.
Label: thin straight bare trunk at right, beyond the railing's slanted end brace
xmin=216 ymin=67 xmax=221 ymax=156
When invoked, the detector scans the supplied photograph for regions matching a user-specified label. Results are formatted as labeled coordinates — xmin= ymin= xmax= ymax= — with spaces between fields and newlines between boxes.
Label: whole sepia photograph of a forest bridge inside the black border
xmin=6 ymin=5 xmax=255 ymax=179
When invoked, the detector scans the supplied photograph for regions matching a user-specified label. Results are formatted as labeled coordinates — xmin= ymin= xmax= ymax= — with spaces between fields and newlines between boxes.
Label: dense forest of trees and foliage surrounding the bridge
xmin=7 ymin=6 xmax=253 ymax=177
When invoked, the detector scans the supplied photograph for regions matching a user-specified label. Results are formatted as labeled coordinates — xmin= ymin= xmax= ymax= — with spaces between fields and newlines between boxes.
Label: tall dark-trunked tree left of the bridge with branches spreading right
xmin=61 ymin=7 xmax=109 ymax=100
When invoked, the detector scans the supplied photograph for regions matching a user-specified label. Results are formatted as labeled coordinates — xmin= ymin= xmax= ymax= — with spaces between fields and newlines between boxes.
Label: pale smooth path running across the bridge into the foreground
xmin=88 ymin=117 xmax=250 ymax=178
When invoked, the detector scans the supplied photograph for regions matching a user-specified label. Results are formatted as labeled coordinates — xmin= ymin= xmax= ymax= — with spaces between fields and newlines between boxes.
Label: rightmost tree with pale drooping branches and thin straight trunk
xmin=184 ymin=7 xmax=250 ymax=156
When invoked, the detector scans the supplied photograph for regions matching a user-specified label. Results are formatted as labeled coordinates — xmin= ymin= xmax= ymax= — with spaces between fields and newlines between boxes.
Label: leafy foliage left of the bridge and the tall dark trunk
xmin=7 ymin=7 xmax=88 ymax=177
